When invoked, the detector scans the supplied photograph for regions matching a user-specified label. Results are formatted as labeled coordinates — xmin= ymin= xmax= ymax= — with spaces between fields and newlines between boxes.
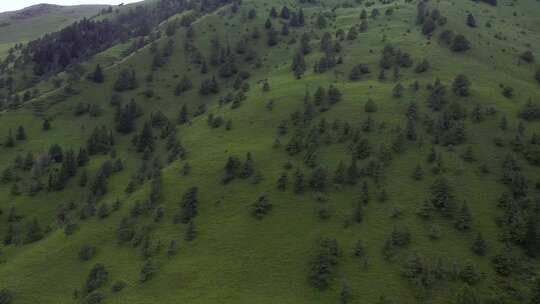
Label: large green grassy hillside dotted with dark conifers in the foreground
xmin=0 ymin=0 xmax=540 ymax=304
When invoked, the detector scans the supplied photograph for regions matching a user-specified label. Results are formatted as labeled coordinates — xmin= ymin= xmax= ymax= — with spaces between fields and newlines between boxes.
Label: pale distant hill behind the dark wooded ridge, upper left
xmin=0 ymin=4 xmax=108 ymax=57
